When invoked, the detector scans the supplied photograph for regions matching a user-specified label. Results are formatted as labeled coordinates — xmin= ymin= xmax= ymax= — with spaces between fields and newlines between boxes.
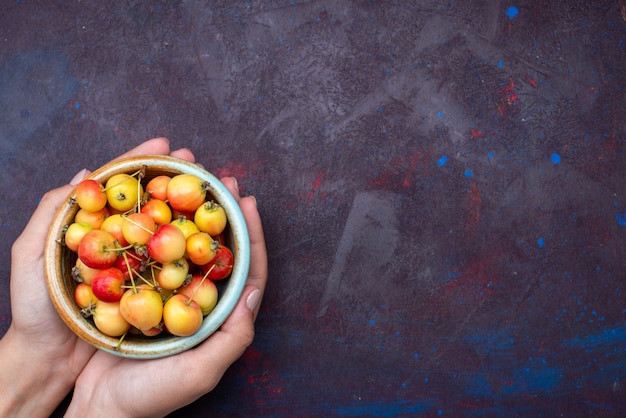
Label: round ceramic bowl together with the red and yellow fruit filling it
xmin=44 ymin=156 xmax=250 ymax=358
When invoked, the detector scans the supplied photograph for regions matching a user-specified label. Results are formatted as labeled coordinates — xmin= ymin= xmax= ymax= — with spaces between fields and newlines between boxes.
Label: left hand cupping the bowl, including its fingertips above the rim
xmin=0 ymin=138 xmax=195 ymax=417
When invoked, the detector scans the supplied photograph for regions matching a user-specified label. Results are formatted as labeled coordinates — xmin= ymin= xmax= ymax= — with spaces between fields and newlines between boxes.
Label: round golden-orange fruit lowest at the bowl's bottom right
xmin=163 ymin=293 xmax=203 ymax=337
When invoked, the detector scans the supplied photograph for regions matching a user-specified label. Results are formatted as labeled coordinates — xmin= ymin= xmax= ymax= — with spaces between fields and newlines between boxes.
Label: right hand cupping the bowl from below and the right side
xmin=67 ymin=172 xmax=268 ymax=417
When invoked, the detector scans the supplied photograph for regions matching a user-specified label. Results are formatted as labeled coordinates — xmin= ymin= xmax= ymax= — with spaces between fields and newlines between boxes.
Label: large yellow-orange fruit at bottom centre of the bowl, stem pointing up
xmin=120 ymin=286 xmax=163 ymax=330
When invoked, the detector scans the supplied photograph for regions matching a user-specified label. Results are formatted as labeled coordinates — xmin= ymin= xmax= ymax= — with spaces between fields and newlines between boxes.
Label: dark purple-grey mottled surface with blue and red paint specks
xmin=0 ymin=0 xmax=626 ymax=417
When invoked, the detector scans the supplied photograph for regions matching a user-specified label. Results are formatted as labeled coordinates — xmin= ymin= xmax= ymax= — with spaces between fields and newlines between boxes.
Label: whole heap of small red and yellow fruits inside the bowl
xmin=63 ymin=167 xmax=233 ymax=341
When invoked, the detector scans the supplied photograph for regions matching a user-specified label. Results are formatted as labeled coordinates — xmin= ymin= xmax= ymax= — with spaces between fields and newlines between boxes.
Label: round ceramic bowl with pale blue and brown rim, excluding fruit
xmin=44 ymin=156 xmax=250 ymax=359
